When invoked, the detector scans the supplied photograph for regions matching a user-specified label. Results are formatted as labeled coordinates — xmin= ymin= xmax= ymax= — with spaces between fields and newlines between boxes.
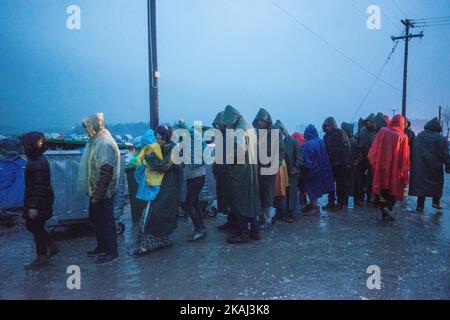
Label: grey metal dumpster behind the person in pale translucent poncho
xmin=45 ymin=150 xmax=126 ymax=234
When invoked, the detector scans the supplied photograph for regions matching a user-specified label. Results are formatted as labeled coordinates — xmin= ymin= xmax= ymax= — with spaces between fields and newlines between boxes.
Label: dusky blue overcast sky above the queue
xmin=0 ymin=0 xmax=450 ymax=134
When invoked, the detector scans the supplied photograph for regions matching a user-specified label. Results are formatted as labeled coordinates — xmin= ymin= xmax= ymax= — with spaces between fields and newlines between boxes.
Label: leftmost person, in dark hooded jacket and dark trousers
xmin=21 ymin=132 xmax=58 ymax=269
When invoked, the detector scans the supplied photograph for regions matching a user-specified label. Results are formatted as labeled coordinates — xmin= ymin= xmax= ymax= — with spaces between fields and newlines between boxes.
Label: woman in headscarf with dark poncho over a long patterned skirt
xmin=133 ymin=125 xmax=181 ymax=256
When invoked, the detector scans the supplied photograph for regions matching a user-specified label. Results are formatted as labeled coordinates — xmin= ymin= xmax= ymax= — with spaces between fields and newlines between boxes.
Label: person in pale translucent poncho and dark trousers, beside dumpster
xmin=78 ymin=113 xmax=120 ymax=264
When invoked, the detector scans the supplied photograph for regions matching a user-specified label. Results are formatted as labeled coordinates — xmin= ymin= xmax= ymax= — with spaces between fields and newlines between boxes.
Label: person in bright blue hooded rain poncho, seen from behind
xmin=302 ymin=124 xmax=335 ymax=213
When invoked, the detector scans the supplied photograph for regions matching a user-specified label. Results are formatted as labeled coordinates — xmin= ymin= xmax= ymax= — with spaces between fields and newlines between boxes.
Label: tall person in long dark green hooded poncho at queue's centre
xmin=223 ymin=106 xmax=261 ymax=244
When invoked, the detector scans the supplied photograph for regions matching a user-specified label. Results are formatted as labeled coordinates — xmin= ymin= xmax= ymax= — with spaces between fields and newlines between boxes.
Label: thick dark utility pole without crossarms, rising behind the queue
xmin=147 ymin=0 xmax=160 ymax=130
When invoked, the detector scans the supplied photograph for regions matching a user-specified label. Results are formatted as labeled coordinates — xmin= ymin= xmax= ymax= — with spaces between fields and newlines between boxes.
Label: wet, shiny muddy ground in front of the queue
xmin=0 ymin=177 xmax=450 ymax=299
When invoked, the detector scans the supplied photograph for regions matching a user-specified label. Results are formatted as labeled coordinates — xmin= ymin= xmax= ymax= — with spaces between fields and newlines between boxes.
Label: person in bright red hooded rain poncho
xmin=368 ymin=115 xmax=410 ymax=220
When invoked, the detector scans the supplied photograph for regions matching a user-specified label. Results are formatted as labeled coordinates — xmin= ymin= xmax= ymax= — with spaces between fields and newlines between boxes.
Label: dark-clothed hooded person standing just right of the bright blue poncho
xmin=322 ymin=117 xmax=352 ymax=210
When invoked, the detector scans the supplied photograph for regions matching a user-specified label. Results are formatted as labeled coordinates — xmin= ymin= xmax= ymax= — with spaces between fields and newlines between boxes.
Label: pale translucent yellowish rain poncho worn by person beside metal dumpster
xmin=78 ymin=113 xmax=120 ymax=198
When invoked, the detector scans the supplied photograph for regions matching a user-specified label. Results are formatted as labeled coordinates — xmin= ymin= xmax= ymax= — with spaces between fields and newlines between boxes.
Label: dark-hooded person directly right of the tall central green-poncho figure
xmin=253 ymin=109 xmax=284 ymax=228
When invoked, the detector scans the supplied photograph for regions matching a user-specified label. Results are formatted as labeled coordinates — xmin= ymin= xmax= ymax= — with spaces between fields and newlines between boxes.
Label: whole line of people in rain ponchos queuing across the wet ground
xmin=18 ymin=106 xmax=450 ymax=268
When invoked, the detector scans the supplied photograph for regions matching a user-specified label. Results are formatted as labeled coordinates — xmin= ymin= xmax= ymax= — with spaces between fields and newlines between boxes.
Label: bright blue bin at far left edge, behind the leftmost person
xmin=0 ymin=157 xmax=26 ymax=209
